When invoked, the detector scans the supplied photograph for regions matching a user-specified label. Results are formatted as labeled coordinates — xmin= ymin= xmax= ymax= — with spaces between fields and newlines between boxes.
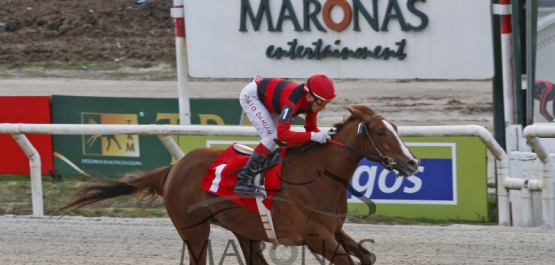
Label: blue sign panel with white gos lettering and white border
xmin=348 ymin=146 xmax=457 ymax=204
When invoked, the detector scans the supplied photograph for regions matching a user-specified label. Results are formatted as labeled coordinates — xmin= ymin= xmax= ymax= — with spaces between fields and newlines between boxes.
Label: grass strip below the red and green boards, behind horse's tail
xmin=0 ymin=175 xmax=168 ymax=217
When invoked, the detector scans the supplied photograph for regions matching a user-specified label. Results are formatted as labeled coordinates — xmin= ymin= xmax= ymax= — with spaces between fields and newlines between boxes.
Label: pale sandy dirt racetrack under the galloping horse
xmin=0 ymin=216 xmax=555 ymax=265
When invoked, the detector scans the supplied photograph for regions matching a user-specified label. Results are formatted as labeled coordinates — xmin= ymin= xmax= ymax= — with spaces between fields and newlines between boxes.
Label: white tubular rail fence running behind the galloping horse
xmin=0 ymin=124 xmax=555 ymax=227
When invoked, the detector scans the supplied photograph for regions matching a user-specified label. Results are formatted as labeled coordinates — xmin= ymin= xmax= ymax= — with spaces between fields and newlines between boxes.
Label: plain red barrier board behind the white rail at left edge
xmin=0 ymin=96 xmax=53 ymax=174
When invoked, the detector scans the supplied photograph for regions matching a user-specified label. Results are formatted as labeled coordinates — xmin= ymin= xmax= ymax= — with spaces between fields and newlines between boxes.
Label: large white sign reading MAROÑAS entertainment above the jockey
xmin=184 ymin=0 xmax=493 ymax=79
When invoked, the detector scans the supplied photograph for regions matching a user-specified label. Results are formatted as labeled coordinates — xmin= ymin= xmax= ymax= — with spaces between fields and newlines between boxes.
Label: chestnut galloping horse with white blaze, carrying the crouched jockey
xmin=58 ymin=105 xmax=420 ymax=265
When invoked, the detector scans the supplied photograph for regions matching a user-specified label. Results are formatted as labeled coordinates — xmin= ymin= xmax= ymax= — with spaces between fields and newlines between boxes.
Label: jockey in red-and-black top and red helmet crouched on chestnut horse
xmin=235 ymin=74 xmax=336 ymax=194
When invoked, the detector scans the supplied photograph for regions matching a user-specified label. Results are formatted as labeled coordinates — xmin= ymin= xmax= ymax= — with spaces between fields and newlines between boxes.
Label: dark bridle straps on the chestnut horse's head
xmin=328 ymin=114 xmax=397 ymax=170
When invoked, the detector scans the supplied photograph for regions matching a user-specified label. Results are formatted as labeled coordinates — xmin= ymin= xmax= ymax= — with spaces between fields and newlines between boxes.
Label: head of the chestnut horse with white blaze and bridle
xmin=337 ymin=105 xmax=420 ymax=177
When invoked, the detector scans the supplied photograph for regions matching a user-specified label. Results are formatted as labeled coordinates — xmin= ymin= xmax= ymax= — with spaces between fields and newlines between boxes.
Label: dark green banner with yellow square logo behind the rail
xmin=52 ymin=95 xmax=248 ymax=176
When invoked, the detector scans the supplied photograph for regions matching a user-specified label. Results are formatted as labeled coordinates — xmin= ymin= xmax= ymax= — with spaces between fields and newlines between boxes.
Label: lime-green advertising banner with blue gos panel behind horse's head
xmin=348 ymin=137 xmax=487 ymax=221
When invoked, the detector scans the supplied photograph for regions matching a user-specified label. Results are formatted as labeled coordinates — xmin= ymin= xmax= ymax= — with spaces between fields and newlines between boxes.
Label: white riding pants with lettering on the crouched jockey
xmin=239 ymin=76 xmax=279 ymax=151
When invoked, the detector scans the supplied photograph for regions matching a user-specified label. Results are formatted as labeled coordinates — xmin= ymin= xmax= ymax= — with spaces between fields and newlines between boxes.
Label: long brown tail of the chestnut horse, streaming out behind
xmin=54 ymin=166 xmax=172 ymax=214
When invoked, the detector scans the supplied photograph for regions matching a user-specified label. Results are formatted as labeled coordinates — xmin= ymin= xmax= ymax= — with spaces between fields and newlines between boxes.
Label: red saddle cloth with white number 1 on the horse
xmin=201 ymin=145 xmax=286 ymax=212
